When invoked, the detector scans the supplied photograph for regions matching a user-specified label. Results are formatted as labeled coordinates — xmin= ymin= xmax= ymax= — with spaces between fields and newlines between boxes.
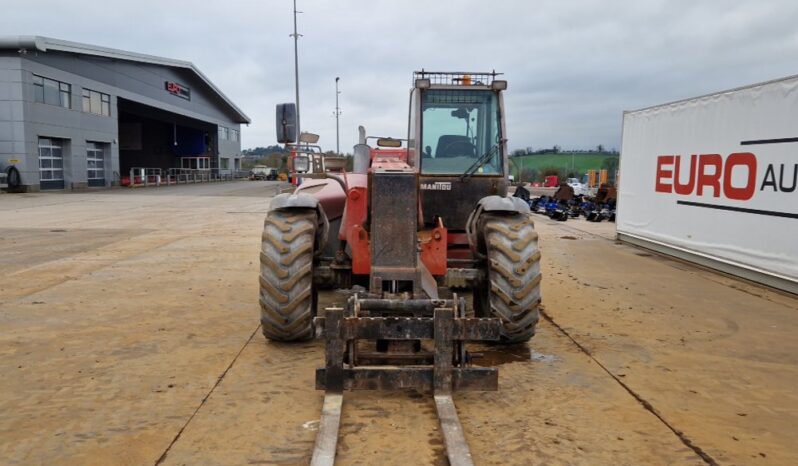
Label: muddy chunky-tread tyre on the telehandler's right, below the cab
xmin=475 ymin=214 xmax=541 ymax=343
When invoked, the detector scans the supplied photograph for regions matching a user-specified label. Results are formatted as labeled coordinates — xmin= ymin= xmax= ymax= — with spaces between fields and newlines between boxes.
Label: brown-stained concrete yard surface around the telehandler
xmin=0 ymin=182 xmax=798 ymax=465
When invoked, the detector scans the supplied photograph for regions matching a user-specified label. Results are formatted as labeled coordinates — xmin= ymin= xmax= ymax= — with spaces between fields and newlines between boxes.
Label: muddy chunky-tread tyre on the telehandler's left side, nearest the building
xmin=260 ymin=209 xmax=318 ymax=341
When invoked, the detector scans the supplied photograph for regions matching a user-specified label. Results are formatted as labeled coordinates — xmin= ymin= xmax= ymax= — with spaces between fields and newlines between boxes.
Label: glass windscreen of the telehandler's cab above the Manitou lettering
xmin=421 ymin=89 xmax=502 ymax=175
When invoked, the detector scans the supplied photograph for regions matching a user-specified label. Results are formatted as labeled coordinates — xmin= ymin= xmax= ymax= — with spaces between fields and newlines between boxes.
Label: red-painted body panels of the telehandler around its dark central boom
xmin=296 ymin=149 xmax=454 ymax=276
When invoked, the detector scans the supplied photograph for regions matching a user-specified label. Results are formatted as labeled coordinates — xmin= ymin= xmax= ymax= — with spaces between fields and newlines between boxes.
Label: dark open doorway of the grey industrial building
xmin=118 ymin=98 xmax=219 ymax=185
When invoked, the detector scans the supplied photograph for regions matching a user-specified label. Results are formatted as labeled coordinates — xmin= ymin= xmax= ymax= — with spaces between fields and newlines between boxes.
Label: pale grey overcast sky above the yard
xmin=0 ymin=0 xmax=798 ymax=152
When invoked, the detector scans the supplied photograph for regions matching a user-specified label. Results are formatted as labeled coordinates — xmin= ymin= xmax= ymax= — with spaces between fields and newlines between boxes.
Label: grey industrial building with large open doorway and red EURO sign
xmin=0 ymin=36 xmax=250 ymax=191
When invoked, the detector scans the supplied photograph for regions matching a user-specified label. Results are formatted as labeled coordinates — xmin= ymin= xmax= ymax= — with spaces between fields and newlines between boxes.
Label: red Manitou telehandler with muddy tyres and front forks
xmin=260 ymin=70 xmax=540 ymax=465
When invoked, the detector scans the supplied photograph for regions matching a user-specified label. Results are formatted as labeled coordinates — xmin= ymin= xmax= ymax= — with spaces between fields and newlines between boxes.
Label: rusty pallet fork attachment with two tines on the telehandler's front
xmin=311 ymin=294 xmax=501 ymax=466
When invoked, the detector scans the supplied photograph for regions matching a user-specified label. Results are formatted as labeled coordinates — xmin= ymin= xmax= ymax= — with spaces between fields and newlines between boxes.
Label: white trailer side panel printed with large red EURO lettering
xmin=617 ymin=76 xmax=798 ymax=283
